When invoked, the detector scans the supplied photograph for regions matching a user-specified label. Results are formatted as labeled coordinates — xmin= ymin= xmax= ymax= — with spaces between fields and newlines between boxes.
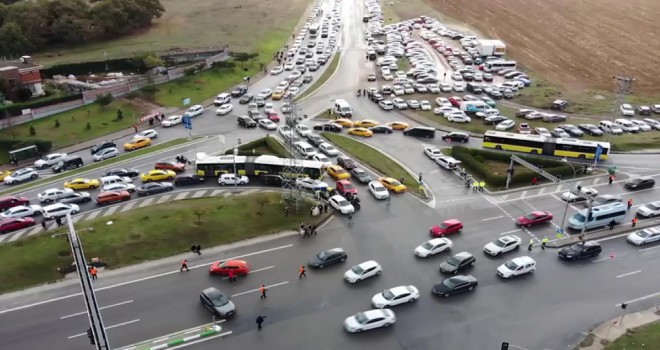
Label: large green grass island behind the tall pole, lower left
xmin=0 ymin=192 xmax=321 ymax=292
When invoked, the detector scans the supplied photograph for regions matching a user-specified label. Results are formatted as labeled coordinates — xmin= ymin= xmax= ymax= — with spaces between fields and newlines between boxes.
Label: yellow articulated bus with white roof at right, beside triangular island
xmin=483 ymin=130 xmax=610 ymax=160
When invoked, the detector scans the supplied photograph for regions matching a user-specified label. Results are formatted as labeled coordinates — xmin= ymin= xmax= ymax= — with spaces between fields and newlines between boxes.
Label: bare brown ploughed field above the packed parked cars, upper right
xmin=425 ymin=0 xmax=660 ymax=94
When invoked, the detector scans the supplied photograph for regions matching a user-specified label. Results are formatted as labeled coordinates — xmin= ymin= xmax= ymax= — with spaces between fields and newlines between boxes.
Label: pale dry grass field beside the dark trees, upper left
xmin=35 ymin=0 xmax=311 ymax=65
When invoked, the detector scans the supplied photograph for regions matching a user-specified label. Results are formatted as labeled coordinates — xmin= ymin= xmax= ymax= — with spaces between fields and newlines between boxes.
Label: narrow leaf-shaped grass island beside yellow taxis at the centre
xmin=321 ymin=132 xmax=424 ymax=195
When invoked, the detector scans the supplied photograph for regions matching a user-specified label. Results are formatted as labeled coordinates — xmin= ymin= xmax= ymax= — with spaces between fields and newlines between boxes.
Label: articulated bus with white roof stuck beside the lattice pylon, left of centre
xmin=195 ymin=153 xmax=324 ymax=179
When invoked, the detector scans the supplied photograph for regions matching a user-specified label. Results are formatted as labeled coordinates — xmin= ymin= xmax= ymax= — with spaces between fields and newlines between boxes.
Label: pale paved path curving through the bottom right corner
xmin=576 ymin=306 xmax=660 ymax=350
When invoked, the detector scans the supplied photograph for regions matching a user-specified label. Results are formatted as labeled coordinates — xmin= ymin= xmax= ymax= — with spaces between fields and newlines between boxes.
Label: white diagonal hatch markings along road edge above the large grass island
xmin=0 ymin=188 xmax=250 ymax=244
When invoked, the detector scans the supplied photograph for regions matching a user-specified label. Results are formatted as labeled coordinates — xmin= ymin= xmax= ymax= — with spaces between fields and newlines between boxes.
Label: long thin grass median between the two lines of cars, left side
xmin=0 ymin=139 xmax=195 ymax=196
